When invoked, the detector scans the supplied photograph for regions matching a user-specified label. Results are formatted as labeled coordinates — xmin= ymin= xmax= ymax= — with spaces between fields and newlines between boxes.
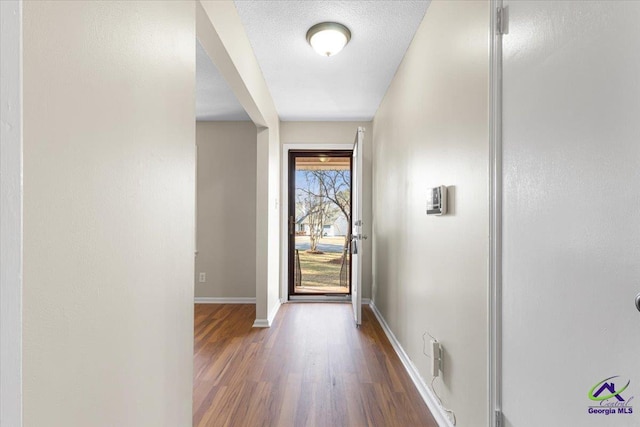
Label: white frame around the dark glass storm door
xmin=280 ymin=142 xmax=353 ymax=303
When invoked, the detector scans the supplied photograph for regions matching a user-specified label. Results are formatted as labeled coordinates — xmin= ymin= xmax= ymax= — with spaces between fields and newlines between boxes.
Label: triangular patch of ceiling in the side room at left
xmin=196 ymin=40 xmax=251 ymax=121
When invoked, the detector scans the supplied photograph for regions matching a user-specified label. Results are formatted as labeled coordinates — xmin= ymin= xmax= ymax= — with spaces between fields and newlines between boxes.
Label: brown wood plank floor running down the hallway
xmin=193 ymin=303 xmax=437 ymax=427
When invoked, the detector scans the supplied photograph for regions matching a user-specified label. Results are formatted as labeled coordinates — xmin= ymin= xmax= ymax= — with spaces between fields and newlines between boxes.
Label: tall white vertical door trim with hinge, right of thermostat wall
xmin=487 ymin=0 xmax=504 ymax=426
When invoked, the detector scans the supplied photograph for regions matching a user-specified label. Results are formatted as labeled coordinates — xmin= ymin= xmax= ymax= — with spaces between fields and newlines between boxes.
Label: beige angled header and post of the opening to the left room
xmin=196 ymin=0 xmax=280 ymax=326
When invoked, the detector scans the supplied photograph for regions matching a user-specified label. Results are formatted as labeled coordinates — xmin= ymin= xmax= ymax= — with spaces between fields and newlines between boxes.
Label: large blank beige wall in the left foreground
xmin=23 ymin=1 xmax=195 ymax=427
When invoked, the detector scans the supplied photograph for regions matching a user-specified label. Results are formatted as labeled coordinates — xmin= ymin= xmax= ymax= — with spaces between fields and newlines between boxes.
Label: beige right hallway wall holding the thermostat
xmin=373 ymin=1 xmax=489 ymax=427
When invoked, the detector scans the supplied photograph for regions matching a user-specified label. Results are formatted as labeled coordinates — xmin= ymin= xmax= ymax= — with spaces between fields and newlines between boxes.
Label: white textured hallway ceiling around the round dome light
xmin=235 ymin=0 xmax=429 ymax=121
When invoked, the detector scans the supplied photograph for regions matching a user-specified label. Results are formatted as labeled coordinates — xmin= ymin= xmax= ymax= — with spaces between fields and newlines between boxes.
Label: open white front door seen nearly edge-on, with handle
xmin=351 ymin=127 xmax=367 ymax=326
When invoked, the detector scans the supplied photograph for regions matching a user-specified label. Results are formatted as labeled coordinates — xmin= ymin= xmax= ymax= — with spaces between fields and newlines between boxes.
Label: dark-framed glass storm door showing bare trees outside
xmin=287 ymin=150 xmax=353 ymax=298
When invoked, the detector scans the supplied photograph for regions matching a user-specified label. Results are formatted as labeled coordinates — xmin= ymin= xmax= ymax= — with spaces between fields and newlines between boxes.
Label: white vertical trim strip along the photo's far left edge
xmin=0 ymin=0 xmax=23 ymax=427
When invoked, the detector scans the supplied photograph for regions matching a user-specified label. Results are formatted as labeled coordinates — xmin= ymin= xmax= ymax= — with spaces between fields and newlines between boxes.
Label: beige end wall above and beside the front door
xmin=280 ymin=122 xmax=373 ymax=298
